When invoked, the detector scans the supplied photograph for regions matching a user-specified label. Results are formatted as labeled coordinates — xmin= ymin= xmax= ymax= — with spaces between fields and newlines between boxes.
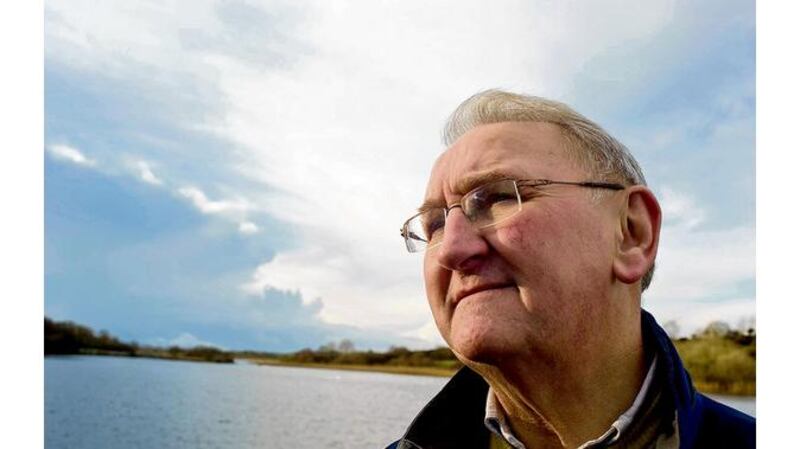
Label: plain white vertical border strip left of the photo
xmin=0 ymin=0 xmax=44 ymax=448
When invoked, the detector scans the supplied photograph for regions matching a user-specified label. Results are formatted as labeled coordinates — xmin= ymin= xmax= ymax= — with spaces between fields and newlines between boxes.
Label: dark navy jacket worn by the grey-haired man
xmin=386 ymin=310 xmax=756 ymax=449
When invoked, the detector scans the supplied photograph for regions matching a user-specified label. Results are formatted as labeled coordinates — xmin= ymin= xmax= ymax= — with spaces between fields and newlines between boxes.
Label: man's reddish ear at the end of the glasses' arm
xmin=613 ymin=186 xmax=661 ymax=284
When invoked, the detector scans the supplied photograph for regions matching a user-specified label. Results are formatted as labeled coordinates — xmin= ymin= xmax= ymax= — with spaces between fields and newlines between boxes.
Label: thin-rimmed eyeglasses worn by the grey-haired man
xmin=400 ymin=179 xmax=625 ymax=253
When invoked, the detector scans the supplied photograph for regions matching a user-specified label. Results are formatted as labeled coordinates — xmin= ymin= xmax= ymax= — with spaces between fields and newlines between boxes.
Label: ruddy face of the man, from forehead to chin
xmin=425 ymin=122 xmax=620 ymax=363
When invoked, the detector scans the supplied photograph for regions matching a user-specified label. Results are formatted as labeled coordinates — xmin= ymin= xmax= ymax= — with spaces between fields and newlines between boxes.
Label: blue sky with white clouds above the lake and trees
xmin=42 ymin=0 xmax=756 ymax=351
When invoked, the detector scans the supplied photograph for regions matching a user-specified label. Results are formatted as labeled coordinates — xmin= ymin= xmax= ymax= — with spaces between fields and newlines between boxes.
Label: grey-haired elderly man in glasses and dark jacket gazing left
xmin=389 ymin=91 xmax=755 ymax=449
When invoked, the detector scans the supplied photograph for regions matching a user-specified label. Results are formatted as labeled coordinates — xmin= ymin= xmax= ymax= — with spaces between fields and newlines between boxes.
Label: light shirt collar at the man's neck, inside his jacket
xmin=483 ymin=355 xmax=656 ymax=449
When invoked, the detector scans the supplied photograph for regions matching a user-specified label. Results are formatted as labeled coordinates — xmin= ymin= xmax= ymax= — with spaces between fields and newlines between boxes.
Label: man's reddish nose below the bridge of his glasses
xmin=434 ymin=207 xmax=489 ymax=273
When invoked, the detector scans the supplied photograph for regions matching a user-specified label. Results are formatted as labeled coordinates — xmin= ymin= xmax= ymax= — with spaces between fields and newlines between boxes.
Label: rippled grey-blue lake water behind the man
xmin=44 ymin=356 xmax=755 ymax=449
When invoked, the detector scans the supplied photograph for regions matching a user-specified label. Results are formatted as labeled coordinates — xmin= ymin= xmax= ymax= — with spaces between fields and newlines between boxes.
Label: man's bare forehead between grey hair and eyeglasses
xmin=426 ymin=122 xmax=583 ymax=203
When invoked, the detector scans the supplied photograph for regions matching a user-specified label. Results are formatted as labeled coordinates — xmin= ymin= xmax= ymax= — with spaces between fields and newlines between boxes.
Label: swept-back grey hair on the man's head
xmin=442 ymin=89 xmax=655 ymax=291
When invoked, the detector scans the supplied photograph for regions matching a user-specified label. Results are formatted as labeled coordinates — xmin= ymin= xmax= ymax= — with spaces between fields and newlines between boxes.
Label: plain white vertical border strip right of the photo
xmin=756 ymin=1 xmax=800 ymax=442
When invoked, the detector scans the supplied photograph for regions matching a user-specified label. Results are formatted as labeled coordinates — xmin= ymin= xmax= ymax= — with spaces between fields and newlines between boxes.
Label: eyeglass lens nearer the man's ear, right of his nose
xmin=463 ymin=180 xmax=522 ymax=228
